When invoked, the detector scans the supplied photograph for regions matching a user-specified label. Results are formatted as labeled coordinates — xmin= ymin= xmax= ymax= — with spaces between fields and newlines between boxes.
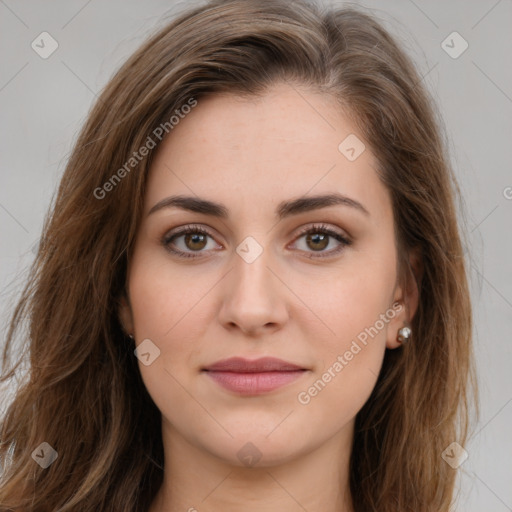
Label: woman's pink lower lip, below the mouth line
xmin=205 ymin=370 xmax=305 ymax=395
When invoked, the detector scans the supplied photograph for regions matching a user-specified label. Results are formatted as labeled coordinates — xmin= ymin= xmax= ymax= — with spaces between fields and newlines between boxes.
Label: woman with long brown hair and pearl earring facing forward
xmin=0 ymin=0 xmax=474 ymax=512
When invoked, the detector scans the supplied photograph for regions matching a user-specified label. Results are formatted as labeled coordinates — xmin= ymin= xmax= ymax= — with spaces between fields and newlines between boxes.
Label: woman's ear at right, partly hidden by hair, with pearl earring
xmin=386 ymin=248 xmax=423 ymax=349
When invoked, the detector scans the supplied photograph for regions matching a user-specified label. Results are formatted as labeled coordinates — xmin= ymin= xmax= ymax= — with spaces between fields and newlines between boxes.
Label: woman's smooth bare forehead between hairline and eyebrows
xmin=145 ymin=85 xmax=390 ymax=221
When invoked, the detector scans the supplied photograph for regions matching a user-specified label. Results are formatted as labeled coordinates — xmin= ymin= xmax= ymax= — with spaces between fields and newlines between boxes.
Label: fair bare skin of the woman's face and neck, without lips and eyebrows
xmin=120 ymin=84 xmax=417 ymax=512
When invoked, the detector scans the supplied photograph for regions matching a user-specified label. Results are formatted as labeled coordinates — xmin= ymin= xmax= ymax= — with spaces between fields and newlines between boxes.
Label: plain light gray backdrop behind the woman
xmin=0 ymin=0 xmax=512 ymax=512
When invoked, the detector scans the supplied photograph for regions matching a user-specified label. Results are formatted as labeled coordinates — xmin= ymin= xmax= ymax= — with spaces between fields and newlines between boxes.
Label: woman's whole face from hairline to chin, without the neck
xmin=120 ymin=85 xmax=411 ymax=466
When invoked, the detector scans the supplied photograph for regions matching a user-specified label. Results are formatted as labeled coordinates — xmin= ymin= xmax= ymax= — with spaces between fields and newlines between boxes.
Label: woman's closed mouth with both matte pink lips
xmin=201 ymin=357 xmax=309 ymax=396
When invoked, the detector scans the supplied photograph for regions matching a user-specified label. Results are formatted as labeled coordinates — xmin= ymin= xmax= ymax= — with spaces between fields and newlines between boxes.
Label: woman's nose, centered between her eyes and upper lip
xmin=219 ymin=243 xmax=289 ymax=336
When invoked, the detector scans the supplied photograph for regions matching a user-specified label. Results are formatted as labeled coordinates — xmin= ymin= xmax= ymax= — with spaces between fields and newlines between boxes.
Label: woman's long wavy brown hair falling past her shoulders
xmin=0 ymin=0 xmax=477 ymax=512
